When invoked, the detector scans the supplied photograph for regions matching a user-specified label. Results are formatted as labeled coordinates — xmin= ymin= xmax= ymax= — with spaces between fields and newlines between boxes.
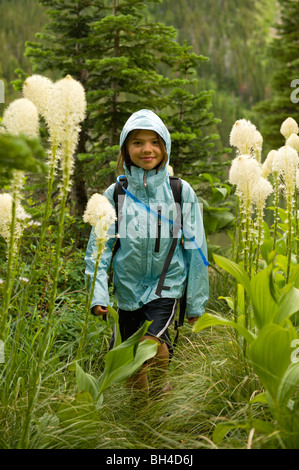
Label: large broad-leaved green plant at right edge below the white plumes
xmin=193 ymin=255 xmax=299 ymax=448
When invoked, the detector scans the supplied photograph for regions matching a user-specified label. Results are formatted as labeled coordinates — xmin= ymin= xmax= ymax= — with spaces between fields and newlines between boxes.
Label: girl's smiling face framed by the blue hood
xmin=128 ymin=130 xmax=163 ymax=170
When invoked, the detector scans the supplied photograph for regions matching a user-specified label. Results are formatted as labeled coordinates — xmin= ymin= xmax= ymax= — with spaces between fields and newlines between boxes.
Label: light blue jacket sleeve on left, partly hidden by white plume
xmin=85 ymin=184 xmax=116 ymax=308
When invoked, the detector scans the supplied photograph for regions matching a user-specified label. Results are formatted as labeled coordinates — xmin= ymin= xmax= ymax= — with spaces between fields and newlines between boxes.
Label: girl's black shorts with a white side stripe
xmin=112 ymin=298 xmax=178 ymax=349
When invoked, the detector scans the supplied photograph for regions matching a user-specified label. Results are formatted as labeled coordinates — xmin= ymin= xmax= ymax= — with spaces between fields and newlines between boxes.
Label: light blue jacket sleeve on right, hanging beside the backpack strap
xmin=182 ymin=181 xmax=209 ymax=317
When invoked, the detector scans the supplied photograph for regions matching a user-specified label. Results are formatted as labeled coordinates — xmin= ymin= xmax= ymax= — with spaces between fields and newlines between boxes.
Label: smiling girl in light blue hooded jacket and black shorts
xmin=85 ymin=109 xmax=209 ymax=392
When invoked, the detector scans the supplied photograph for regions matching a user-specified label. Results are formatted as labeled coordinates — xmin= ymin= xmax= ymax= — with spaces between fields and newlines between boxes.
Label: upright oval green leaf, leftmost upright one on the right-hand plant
xmin=251 ymin=266 xmax=279 ymax=329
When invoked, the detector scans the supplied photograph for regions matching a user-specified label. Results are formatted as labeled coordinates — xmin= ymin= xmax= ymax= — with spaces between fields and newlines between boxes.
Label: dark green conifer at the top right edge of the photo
xmin=255 ymin=0 xmax=299 ymax=149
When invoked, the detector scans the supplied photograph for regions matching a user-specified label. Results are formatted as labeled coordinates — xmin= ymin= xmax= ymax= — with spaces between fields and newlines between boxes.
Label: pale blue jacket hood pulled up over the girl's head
xmin=120 ymin=109 xmax=171 ymax=161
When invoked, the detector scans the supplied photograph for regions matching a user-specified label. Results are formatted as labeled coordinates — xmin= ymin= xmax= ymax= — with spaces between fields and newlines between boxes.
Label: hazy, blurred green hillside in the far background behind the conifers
xmin=0 ymin=0 xmax=277 ymax=146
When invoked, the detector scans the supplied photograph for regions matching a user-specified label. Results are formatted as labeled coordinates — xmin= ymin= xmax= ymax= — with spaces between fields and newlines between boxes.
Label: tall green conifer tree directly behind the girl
xmin=27 ymin=0 xmax=218 ymax=213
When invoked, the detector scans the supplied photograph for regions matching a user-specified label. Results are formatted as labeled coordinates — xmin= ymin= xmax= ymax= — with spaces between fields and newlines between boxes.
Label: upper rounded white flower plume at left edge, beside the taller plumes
xmin=2 ymin=98 xmax=39 ymax=137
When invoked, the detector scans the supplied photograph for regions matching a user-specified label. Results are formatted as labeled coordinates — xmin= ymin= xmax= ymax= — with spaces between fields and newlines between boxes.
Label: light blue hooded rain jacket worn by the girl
xmin=85 ymin=110 xmax=209 ymax=317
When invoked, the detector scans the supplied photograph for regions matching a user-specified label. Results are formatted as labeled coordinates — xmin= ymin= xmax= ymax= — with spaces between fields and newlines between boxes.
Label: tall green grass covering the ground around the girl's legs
xmin=0 ymin=260 xmax=281 ymax=449
